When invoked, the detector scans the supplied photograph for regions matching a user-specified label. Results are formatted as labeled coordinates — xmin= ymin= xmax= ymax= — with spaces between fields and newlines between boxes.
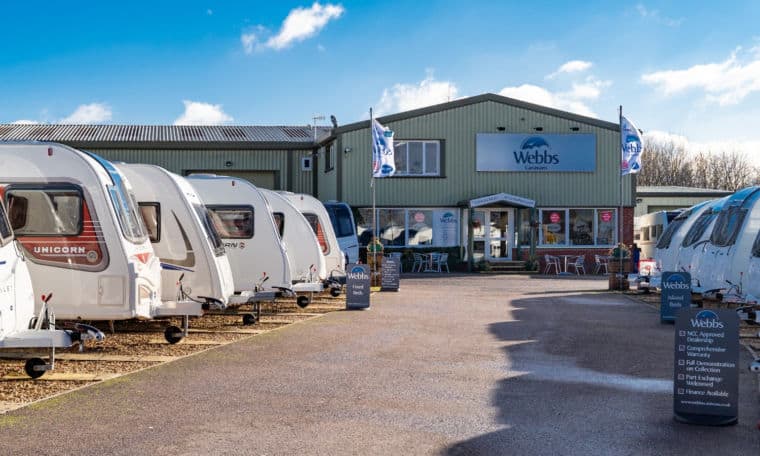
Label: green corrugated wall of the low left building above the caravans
xmin=88 ymin=149 xmax=313 ymax=194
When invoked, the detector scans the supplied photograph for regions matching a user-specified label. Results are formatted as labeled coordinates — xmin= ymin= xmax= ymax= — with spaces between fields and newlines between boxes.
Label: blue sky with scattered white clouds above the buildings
xmin=0 ymin=0 xmax=760 ymax=160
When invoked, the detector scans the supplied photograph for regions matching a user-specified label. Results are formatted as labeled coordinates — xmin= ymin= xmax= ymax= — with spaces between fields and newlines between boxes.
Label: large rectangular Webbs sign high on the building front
xmin=475 ymin=133 xmax=596 ymax=173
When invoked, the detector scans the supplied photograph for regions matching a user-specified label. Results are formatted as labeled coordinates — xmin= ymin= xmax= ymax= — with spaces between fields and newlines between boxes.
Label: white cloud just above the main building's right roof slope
xmin=499 ymin=76 xmax=611 ymax=117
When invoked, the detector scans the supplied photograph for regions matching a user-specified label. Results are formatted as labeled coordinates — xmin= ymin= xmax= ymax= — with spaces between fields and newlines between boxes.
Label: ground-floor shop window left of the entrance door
xmin=356 ymin=208 xmax=459 ymax=247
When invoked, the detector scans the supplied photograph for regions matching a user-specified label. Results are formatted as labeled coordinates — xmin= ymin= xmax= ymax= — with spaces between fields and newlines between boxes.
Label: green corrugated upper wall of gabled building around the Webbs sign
xmin=338 ymin=101 xmax=632 ymax=207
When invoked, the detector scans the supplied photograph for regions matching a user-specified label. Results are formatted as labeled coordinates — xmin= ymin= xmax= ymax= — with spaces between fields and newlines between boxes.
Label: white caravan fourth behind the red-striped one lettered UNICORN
xmin=279 ymin=192 xmax=346 ymax=293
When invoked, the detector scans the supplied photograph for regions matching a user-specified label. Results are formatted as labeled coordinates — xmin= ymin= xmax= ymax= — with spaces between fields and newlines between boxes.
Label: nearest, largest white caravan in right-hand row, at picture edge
xmin=694 ymin=187 xmax=760 ymax=299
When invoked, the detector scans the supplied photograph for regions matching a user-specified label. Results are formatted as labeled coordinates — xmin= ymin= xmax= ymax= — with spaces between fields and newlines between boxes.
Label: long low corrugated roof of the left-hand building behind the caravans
xmin=0 ymin=124 xmax=331 ymax=147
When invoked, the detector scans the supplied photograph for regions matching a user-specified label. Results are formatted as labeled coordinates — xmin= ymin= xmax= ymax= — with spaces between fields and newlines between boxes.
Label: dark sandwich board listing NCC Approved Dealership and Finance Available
xmin=673 ymin=308 xmax=739 ymax=426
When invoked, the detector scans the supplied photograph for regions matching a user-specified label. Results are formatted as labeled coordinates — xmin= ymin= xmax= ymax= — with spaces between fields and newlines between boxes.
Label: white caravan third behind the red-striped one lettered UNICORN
xmin=259 ymin=188 xmax=327 ymax=293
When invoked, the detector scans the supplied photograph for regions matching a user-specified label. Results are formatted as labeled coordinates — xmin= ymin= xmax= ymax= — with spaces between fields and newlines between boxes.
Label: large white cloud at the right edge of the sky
xmin=641 ymin=48 xmax=760 ymax=106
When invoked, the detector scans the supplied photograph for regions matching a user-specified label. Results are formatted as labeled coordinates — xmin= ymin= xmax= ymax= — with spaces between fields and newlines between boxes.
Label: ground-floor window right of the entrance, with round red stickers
xmin=539 ymin=209 xmax=617 ymax=247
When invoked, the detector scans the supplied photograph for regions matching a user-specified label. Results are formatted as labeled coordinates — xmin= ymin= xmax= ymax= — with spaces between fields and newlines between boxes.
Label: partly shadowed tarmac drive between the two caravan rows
xmin=0 ymin=274 xmax=760 ymax=456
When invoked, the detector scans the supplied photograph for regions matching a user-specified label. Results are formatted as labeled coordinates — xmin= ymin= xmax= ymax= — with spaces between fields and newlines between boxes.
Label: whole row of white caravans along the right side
xmin=653 ymin=187 xmax=760 ymax=302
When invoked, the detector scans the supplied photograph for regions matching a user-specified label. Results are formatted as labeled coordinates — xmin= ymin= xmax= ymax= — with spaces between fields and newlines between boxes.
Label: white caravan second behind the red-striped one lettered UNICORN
xmin=187 ymin=174 xmax=292 ymax=294
